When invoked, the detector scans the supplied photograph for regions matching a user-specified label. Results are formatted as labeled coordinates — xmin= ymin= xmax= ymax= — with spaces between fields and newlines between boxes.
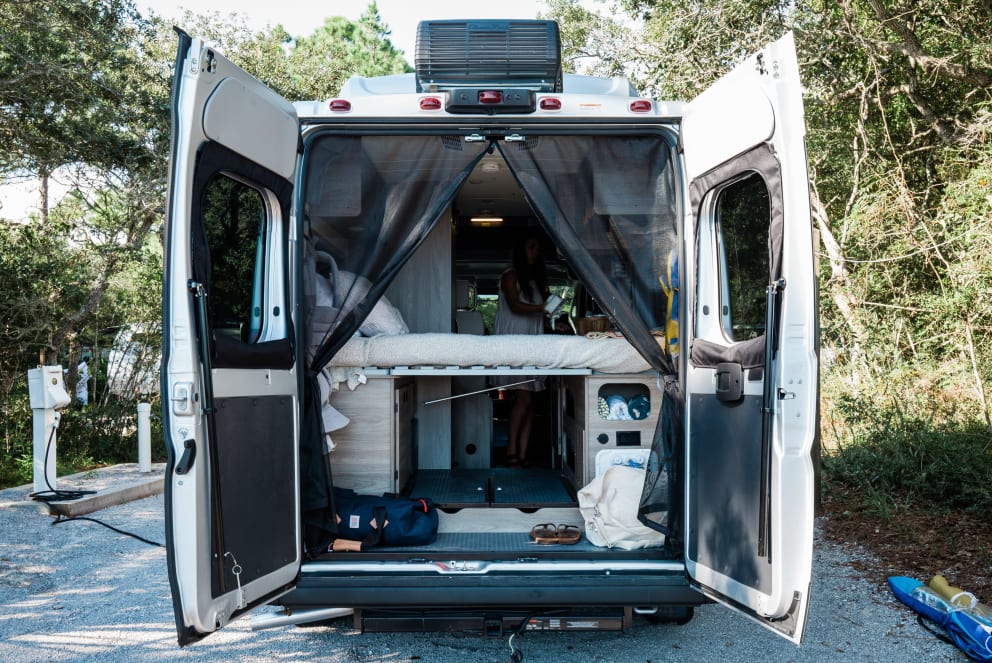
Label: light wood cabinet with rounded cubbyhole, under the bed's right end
xmin=560 ymin=374 xmax=662 ymax=487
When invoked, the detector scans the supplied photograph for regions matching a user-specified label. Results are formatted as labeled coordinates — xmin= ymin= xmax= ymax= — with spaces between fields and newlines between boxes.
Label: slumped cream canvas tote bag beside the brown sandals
xmin=579 ymin=465 xmax=665 ymax=550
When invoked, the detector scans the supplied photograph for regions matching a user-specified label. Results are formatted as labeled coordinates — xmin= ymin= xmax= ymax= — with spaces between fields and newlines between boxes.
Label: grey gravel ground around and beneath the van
xmin=0 ymin=486 xmax=967 ymax=663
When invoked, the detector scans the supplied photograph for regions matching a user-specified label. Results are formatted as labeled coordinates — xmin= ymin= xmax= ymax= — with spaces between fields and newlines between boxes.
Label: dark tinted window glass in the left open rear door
xmin=203 ymin=174 xmax=268 ymax=343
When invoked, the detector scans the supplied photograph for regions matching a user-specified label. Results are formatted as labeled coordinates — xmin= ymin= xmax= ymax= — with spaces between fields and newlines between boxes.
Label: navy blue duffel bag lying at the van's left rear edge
xmin=332 ymin=488 xmax=438 ymax=550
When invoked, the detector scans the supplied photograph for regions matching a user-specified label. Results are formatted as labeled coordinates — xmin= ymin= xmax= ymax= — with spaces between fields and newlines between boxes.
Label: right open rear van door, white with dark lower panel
xmin=682 ymin=34 xmax=818 ymax=643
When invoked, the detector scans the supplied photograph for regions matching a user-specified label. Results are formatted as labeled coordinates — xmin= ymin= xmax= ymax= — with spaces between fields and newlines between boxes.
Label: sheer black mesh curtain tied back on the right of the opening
xmin=500 ymin=135 xmax=685 ymax=540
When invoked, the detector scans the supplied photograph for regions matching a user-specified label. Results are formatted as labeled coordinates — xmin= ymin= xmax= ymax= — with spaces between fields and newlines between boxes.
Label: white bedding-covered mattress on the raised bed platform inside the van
xmin=330 ymin=334 xmax=651 ymax=373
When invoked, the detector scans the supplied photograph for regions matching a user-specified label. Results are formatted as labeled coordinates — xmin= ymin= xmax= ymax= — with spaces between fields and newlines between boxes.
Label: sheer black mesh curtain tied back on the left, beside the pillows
xmin=301 ymin=134 xmax=488 ymax=555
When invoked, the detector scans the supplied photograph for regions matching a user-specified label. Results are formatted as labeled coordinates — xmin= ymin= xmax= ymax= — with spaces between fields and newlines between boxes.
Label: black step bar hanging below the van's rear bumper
xmin=355 ymin=607 xmax=633 ymax=638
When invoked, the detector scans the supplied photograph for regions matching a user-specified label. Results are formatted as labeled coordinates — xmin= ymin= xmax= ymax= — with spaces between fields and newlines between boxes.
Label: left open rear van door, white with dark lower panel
xmin=162 ymin=34 xmax=301 ymax=645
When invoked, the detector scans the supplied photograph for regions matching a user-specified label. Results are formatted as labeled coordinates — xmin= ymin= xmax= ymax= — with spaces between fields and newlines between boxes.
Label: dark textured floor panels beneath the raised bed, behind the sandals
xmin=407 ymin=467 xmax=577 ymax=509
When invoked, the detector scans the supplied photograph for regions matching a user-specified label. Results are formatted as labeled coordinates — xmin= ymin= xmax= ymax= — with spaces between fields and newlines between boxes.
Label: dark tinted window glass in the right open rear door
xmin=716 ymin=173 xmax=771 ymax=341
